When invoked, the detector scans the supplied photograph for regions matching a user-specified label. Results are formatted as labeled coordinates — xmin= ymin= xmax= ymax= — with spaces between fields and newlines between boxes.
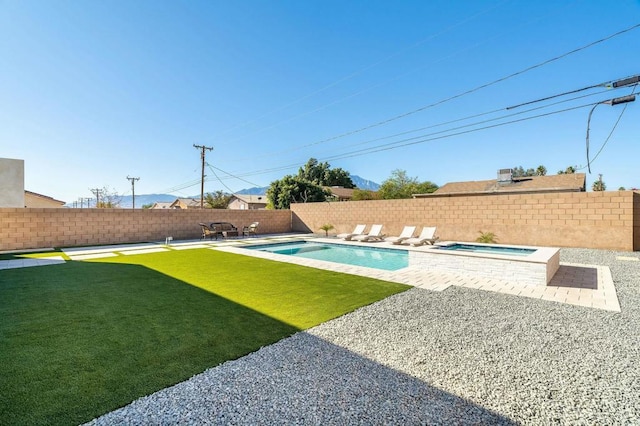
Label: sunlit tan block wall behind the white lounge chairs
xmin=291 ymin=191 xmax=640 ymax=251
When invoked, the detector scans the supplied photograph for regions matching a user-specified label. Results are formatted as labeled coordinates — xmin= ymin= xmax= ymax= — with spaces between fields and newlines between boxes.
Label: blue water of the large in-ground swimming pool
xmin=245 ymin=241 xmax=409 ymax=271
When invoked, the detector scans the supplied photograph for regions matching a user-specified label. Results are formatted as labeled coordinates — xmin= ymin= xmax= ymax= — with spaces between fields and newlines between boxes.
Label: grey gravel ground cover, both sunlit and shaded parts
xmin=91 ymin=249 xmax=640 ymax=425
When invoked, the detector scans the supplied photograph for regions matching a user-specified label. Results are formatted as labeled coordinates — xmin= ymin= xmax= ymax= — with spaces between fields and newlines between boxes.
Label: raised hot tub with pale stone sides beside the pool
xmin=409 ymin=242 xmax=560 ymax=286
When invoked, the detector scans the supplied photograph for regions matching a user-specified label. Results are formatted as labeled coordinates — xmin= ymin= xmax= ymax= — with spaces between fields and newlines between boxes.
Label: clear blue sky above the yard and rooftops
xmin=0 ymin=0 xmax=640 ymax=202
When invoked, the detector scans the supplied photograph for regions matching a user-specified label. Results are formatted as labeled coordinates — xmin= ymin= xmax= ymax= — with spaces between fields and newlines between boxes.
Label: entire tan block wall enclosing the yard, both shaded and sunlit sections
xmin=0 ymin=191 xmax=640 ymax=251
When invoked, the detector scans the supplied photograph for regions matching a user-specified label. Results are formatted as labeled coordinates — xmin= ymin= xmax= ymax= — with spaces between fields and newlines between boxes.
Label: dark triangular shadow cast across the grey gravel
xmin=92 ymin=332 xmax=517 ymax=425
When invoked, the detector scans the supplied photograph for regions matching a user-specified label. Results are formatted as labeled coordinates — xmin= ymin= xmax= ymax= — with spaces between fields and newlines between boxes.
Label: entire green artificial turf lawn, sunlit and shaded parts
xmin=0 ymin=249 xmax=408 ymax=425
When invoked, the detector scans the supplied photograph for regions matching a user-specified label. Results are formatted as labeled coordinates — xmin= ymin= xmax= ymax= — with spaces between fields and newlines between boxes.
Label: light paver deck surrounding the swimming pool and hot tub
xmin=0 ymin=234 xmax=620 ymax=312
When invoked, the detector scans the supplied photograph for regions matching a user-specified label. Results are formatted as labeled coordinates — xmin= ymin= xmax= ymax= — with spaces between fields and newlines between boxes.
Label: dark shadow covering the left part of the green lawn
xmin=0 ymin=262 xmax=298 ymax=425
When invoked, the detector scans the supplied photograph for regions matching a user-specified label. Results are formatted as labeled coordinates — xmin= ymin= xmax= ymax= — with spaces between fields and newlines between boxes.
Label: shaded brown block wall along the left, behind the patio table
xmin=0 ymin=208 xmax=291 ymax=251
